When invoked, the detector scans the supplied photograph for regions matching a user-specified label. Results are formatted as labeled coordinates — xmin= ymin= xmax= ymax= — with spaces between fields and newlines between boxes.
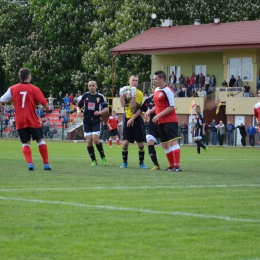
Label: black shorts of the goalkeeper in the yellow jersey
xmin=123 ymin=116 xmax=145 ymax=143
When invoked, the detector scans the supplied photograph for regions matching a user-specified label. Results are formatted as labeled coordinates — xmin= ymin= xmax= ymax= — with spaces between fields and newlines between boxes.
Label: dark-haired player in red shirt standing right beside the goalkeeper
xmin=146 ymin=70 xmax=181 ymax=172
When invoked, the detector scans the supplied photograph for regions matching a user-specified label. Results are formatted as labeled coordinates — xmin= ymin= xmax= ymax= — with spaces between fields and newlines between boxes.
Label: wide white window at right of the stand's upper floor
xmin=228 ymin=58 xmax=253 ymax=81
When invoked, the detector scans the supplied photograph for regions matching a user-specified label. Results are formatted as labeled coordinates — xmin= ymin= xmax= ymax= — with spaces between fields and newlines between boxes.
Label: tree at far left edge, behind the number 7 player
xmin=0 ymin=0 xmax=32 ymax=93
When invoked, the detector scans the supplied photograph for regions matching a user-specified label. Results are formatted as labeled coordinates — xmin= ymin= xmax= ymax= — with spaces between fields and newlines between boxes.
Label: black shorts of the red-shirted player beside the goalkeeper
xmin=159 ymin=122 xmax=180 ymax=143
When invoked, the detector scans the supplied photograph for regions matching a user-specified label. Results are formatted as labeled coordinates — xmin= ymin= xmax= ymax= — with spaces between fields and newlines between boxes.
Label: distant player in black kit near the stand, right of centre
xmin=190 ymin=106 xmax=208 ymax=154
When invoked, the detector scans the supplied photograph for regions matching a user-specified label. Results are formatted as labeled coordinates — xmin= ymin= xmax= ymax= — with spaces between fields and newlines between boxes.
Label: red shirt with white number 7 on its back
xmin=6 ymin=83 xmax=47 ymax=130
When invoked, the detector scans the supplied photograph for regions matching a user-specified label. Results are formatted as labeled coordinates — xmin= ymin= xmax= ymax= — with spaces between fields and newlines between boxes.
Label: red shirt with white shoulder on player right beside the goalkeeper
xmin=153 ymin=86 xmax=178 ymax=124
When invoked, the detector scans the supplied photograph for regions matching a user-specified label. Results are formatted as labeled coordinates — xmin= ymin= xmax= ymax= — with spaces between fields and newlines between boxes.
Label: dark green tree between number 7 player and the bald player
xmin=26 ymin=0 xmax=93 ymax=93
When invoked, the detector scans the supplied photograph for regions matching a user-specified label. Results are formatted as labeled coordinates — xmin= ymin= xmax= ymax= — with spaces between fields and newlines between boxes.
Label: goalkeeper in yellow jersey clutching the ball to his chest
xmin=120 ymin=75 xmax=147 ymax=169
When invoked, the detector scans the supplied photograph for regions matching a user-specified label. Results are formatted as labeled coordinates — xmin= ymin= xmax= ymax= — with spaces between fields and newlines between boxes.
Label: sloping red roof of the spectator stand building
xmin=111 ymin=20 xmax=260 ymax=54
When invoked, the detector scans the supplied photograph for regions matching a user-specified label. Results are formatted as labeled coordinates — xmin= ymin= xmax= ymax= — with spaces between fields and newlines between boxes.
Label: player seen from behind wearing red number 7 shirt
xmin=0 ymin=68 xmax=51 ymax=170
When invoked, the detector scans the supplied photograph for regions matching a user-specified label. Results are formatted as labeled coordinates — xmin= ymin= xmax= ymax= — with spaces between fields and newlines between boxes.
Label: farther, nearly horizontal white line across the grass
xmin=0 ymin=184 xmax=260 ymax=192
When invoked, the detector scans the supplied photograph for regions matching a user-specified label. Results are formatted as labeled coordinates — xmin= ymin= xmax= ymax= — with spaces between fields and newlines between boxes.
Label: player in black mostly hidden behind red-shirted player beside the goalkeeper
xmin=127 ymin=86 xmax=160 ymax=171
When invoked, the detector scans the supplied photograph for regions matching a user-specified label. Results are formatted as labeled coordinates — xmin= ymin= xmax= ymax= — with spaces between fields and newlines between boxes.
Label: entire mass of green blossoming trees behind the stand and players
xmin=0 ymin=0 xmax=260 ymax=95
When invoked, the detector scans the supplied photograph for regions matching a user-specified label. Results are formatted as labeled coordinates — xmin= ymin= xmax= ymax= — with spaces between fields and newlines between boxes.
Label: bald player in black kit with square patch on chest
xmin=77 ymin=81 xmax=108 ymax=166
